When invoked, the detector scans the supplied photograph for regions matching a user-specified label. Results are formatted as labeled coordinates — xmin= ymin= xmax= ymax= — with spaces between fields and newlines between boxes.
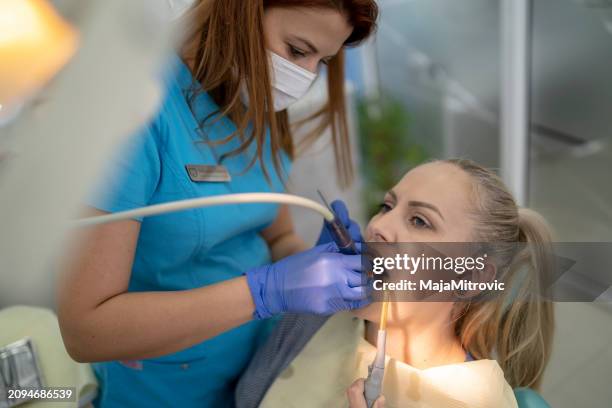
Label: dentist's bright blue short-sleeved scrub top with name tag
xmin=90 ymin=56 xmax=290 ymax=407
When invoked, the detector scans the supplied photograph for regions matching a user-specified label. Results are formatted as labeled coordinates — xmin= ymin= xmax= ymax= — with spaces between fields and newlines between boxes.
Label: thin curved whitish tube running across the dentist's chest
xmin=73 ymin=193 xmax=334 ymax=227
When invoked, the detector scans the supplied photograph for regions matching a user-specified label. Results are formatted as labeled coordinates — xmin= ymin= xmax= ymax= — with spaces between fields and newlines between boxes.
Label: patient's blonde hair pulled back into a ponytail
xmin=443 ymin=159 xmax=554 ymax=389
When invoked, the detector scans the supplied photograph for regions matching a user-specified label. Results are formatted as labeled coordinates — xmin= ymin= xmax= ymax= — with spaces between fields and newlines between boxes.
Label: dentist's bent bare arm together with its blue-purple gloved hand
xmin=58 ymin=212 xmax=366 ymax=362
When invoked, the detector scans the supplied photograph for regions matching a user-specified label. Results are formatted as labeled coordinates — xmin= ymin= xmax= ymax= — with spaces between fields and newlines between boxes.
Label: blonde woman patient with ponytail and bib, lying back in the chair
xmin=237 ymin=160 xmax=553 ymax=408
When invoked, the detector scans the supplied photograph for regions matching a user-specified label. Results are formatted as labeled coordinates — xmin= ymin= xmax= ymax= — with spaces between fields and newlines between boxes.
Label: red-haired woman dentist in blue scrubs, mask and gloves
xmin=58 ymin=0 xmax=377 ymax=407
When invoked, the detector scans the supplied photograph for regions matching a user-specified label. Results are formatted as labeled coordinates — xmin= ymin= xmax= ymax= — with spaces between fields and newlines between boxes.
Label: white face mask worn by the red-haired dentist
xmin=241 ymin=51 xmax=317 ymax=112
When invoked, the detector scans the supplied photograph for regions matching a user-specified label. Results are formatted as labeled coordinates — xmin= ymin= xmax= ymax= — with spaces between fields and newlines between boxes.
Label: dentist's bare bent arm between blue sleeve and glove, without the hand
xmin=58 ymin=210 xmax=254 ymax=362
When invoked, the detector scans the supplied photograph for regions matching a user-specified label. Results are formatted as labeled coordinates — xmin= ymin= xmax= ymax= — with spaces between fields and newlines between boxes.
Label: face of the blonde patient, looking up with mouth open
xmin=355 ymin=162 xmax=474 ymax=325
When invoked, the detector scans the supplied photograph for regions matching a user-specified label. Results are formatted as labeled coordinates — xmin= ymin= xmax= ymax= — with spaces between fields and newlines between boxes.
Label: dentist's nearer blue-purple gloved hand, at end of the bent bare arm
xmin=246 ymin=243 xmax=370 ymax=319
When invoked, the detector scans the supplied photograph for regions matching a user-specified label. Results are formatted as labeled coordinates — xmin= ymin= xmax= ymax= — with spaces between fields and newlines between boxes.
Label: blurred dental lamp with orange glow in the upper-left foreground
xmin=0 ymin=0 xmax=174 ymax=306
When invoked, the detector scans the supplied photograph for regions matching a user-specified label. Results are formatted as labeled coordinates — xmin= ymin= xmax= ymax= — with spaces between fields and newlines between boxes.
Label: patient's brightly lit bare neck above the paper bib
xmin=365 ymin=303 xmax=465 ymax=369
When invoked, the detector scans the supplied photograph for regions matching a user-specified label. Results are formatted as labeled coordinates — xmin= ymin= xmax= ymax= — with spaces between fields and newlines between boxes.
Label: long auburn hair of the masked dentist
xmin=178 ymin=0 xmax=378 ymax=186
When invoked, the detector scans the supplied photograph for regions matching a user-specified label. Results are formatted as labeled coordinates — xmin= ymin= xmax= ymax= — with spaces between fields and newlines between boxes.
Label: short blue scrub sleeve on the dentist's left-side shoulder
xmin=87 ymin=116 xmax=161 ymax=221
